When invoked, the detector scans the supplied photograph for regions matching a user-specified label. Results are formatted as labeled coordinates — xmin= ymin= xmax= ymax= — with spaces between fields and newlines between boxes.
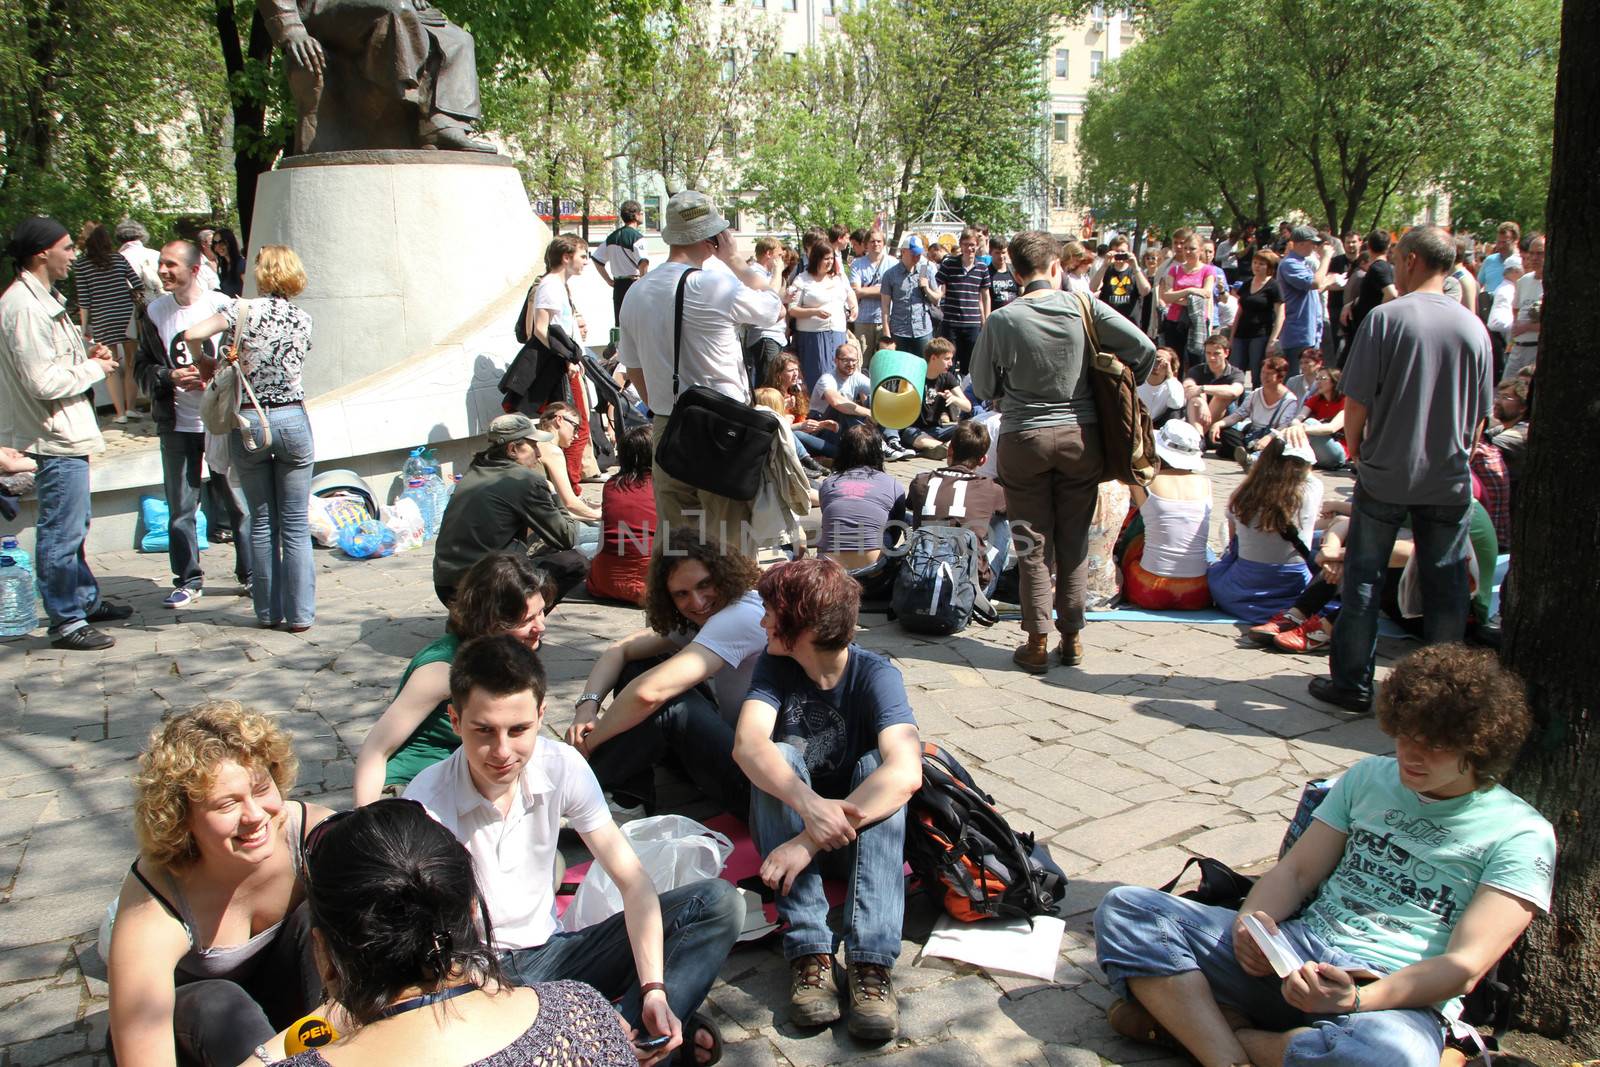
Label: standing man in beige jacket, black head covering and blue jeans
xmin=0 ymin=218 xmax=133 ymax=651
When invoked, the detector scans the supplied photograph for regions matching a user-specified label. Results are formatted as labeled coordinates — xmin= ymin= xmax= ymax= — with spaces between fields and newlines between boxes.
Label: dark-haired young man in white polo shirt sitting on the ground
xmin=405 ymin=635 xmax=744 ymax=1065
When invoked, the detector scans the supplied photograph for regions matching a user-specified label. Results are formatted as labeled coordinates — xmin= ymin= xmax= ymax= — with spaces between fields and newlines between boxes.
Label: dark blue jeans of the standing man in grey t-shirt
xmin=1328 ymin=480 xmax=1472 ymax=696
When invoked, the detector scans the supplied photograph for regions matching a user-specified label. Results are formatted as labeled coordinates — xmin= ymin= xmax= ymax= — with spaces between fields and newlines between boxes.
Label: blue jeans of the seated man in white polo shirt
xmin=501 ymin=878 xmax=744 ymax=1027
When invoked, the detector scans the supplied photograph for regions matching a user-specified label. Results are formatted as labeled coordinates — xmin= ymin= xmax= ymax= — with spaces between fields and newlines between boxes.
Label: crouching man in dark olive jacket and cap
xmin=434 ymin=414 xmax=589 ymax=608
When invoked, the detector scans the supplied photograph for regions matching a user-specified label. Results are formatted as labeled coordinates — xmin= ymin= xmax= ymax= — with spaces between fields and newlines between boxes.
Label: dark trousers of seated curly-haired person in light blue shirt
xmin=589 ymin=657 xmax=750 ymax=814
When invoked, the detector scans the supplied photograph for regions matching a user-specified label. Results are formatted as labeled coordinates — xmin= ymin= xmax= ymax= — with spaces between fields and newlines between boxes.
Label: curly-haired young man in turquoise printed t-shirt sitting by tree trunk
xmin=1094 ymin=645 xmax=1555 ymax=1067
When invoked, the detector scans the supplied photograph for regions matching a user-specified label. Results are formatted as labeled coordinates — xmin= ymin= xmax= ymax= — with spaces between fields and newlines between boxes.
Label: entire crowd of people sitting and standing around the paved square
xmin=0 ymin=192 xmax=1554 ymax=1067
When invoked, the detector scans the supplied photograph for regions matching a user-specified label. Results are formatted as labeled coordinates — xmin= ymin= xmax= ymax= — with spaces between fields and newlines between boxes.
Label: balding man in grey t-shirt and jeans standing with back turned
xmin=1310 ymin=226 xmax=1494 ymax=710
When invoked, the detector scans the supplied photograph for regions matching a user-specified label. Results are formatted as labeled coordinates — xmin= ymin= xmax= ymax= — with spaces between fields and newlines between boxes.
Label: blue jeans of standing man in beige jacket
xmin=34 ymin=454 xmax=99 ymax=635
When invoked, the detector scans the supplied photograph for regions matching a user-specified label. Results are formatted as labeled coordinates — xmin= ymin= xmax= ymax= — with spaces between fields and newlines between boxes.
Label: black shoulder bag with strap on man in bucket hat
xmin=656 ymin=267 xmax=778 ymax=501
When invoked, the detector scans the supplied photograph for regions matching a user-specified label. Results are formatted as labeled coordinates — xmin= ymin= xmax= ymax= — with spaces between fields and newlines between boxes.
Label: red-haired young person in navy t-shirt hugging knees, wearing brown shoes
xmin=733 ymin=560 xmax=922 ymax=1041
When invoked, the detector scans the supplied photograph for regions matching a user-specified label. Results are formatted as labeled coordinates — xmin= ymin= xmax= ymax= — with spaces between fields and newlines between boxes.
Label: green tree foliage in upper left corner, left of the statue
xmin=0 ymin=0 xmax=227 ymax=226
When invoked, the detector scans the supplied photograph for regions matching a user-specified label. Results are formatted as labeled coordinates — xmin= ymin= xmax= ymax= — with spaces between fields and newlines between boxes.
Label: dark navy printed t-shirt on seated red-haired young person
xmin=749 ymin=645 xmax=917 ymax=800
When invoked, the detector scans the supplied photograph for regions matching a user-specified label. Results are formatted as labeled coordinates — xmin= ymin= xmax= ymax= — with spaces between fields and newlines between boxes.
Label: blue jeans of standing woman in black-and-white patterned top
xmin=229 ymin=405 xmax=317 ymax=625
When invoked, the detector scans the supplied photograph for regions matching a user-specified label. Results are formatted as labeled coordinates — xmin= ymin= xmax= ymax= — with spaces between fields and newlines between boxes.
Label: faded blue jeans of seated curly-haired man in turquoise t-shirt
xmin=1094 ymin=886 xmax=1445 ymax=1067
